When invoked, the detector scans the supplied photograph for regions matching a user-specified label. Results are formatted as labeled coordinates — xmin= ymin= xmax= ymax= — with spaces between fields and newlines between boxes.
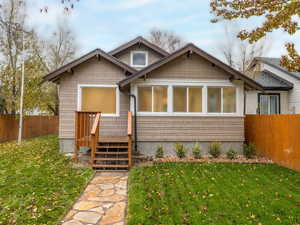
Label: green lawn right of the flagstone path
xmin=128 ymin=163 xmax=300 ymax=225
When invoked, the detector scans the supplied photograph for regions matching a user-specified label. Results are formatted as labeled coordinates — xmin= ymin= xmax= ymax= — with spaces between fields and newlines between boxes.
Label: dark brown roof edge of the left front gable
xmin=43 ymin=49 xmax=136 ymax=81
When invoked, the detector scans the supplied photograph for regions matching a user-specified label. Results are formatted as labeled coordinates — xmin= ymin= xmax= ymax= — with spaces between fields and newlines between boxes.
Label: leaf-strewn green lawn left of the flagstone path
xmin=0 ymin=136 xmax=93 ymax=225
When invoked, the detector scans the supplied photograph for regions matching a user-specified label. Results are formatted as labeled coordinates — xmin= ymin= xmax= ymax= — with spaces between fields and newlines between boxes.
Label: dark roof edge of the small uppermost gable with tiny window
xmin=108 ymin=36 xmax=169 ymax=57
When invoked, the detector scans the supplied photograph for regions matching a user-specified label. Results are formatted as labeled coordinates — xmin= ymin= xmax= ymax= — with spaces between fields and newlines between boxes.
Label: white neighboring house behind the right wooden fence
xmin=246 ymin=57 xmax=300 ymax=114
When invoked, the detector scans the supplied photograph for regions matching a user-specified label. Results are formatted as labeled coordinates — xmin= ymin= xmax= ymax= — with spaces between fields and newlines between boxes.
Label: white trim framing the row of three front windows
xmin=130 ymin=79 xmax=240 ymax=117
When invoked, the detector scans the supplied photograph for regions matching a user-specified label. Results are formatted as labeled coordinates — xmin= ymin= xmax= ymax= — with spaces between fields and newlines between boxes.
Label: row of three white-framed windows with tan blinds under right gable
xmin=132 ymin=81 xmax=237 ymax=116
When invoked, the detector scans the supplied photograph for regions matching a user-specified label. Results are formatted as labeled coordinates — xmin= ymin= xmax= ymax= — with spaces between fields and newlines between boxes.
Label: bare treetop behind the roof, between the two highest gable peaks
xmin=149 ymin=28 xmax=185 ymax=53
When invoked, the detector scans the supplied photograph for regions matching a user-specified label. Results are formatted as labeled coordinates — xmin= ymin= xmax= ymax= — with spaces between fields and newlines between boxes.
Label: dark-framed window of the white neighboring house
xmin=258 ymin=94 xmax=280 ymax=115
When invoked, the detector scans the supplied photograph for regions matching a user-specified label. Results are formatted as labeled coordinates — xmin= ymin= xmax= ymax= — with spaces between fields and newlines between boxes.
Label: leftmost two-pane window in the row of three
xmin=138 ymin=86 xmax=168 ymax=112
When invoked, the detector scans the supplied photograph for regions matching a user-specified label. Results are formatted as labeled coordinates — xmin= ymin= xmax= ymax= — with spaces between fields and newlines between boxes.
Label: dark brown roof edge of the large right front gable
xmin=119 ymin=43 xmax=262 ymax=90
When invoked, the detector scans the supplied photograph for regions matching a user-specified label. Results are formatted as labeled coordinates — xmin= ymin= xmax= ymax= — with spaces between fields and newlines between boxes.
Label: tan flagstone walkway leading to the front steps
xmin=62 ymin=172 xmax=128 ymax=225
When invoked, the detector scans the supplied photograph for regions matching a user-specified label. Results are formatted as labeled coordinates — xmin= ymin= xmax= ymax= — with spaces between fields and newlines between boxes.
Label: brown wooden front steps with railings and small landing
xmin=74 ymin=111 xmax=133 ymax=171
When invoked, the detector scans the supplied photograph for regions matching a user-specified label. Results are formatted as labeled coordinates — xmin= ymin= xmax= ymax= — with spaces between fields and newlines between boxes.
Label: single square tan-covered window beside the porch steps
xmin=80 ymin=86 xmax=117 ymax=115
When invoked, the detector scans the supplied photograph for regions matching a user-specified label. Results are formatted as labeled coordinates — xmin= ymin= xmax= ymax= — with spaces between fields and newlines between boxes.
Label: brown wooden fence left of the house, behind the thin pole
xmin=0 ymin=115 xmax=58 ymax=143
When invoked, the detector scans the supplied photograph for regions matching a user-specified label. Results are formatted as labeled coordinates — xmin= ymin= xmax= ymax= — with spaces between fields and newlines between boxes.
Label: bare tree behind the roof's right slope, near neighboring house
xmin=218 ymin=22 xmax=269 ymax=73
